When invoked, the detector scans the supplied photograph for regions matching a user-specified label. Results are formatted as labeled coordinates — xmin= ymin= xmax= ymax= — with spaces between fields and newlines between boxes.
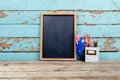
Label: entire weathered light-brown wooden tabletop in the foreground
xmin=0 ymin=61 xmax=120 ymax=80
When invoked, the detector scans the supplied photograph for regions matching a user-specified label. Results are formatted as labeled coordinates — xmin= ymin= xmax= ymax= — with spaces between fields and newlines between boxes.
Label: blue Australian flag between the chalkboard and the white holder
xmin=75 ymin=33 xmax=86 ymax=57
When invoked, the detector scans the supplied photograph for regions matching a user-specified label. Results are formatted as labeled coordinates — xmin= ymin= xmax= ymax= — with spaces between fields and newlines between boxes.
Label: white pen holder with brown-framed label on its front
xmin=85 ymin=47 xmax=99 ymax=62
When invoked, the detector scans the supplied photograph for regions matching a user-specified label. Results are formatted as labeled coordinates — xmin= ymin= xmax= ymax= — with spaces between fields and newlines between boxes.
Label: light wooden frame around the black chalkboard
xmin=40 ymin=12 xmax=76 ymax=60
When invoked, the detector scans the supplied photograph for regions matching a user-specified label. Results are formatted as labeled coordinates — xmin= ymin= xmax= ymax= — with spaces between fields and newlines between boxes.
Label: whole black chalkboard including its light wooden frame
xmin=40 ymin=13 xmax=76 ymax=60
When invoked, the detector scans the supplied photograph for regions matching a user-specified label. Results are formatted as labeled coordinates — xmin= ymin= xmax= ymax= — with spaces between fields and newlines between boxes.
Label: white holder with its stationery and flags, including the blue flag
xmin=75 ymin=33 xmax=99 ymax=62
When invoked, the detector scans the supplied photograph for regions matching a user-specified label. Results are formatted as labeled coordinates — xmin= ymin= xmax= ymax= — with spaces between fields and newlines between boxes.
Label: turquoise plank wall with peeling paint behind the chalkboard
xmin=0 ymin=0 xmax=120 ymax=60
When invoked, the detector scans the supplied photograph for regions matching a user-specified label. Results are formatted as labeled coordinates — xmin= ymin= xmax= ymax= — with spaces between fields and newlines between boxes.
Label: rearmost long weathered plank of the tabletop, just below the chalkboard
xmin=0 ymin=62 xmax=120 ymax=72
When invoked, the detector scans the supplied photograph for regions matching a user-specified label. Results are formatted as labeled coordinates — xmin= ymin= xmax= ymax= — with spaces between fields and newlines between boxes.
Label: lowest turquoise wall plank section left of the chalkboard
xmin=0 ymin=52 xmax=40 ymax=61
